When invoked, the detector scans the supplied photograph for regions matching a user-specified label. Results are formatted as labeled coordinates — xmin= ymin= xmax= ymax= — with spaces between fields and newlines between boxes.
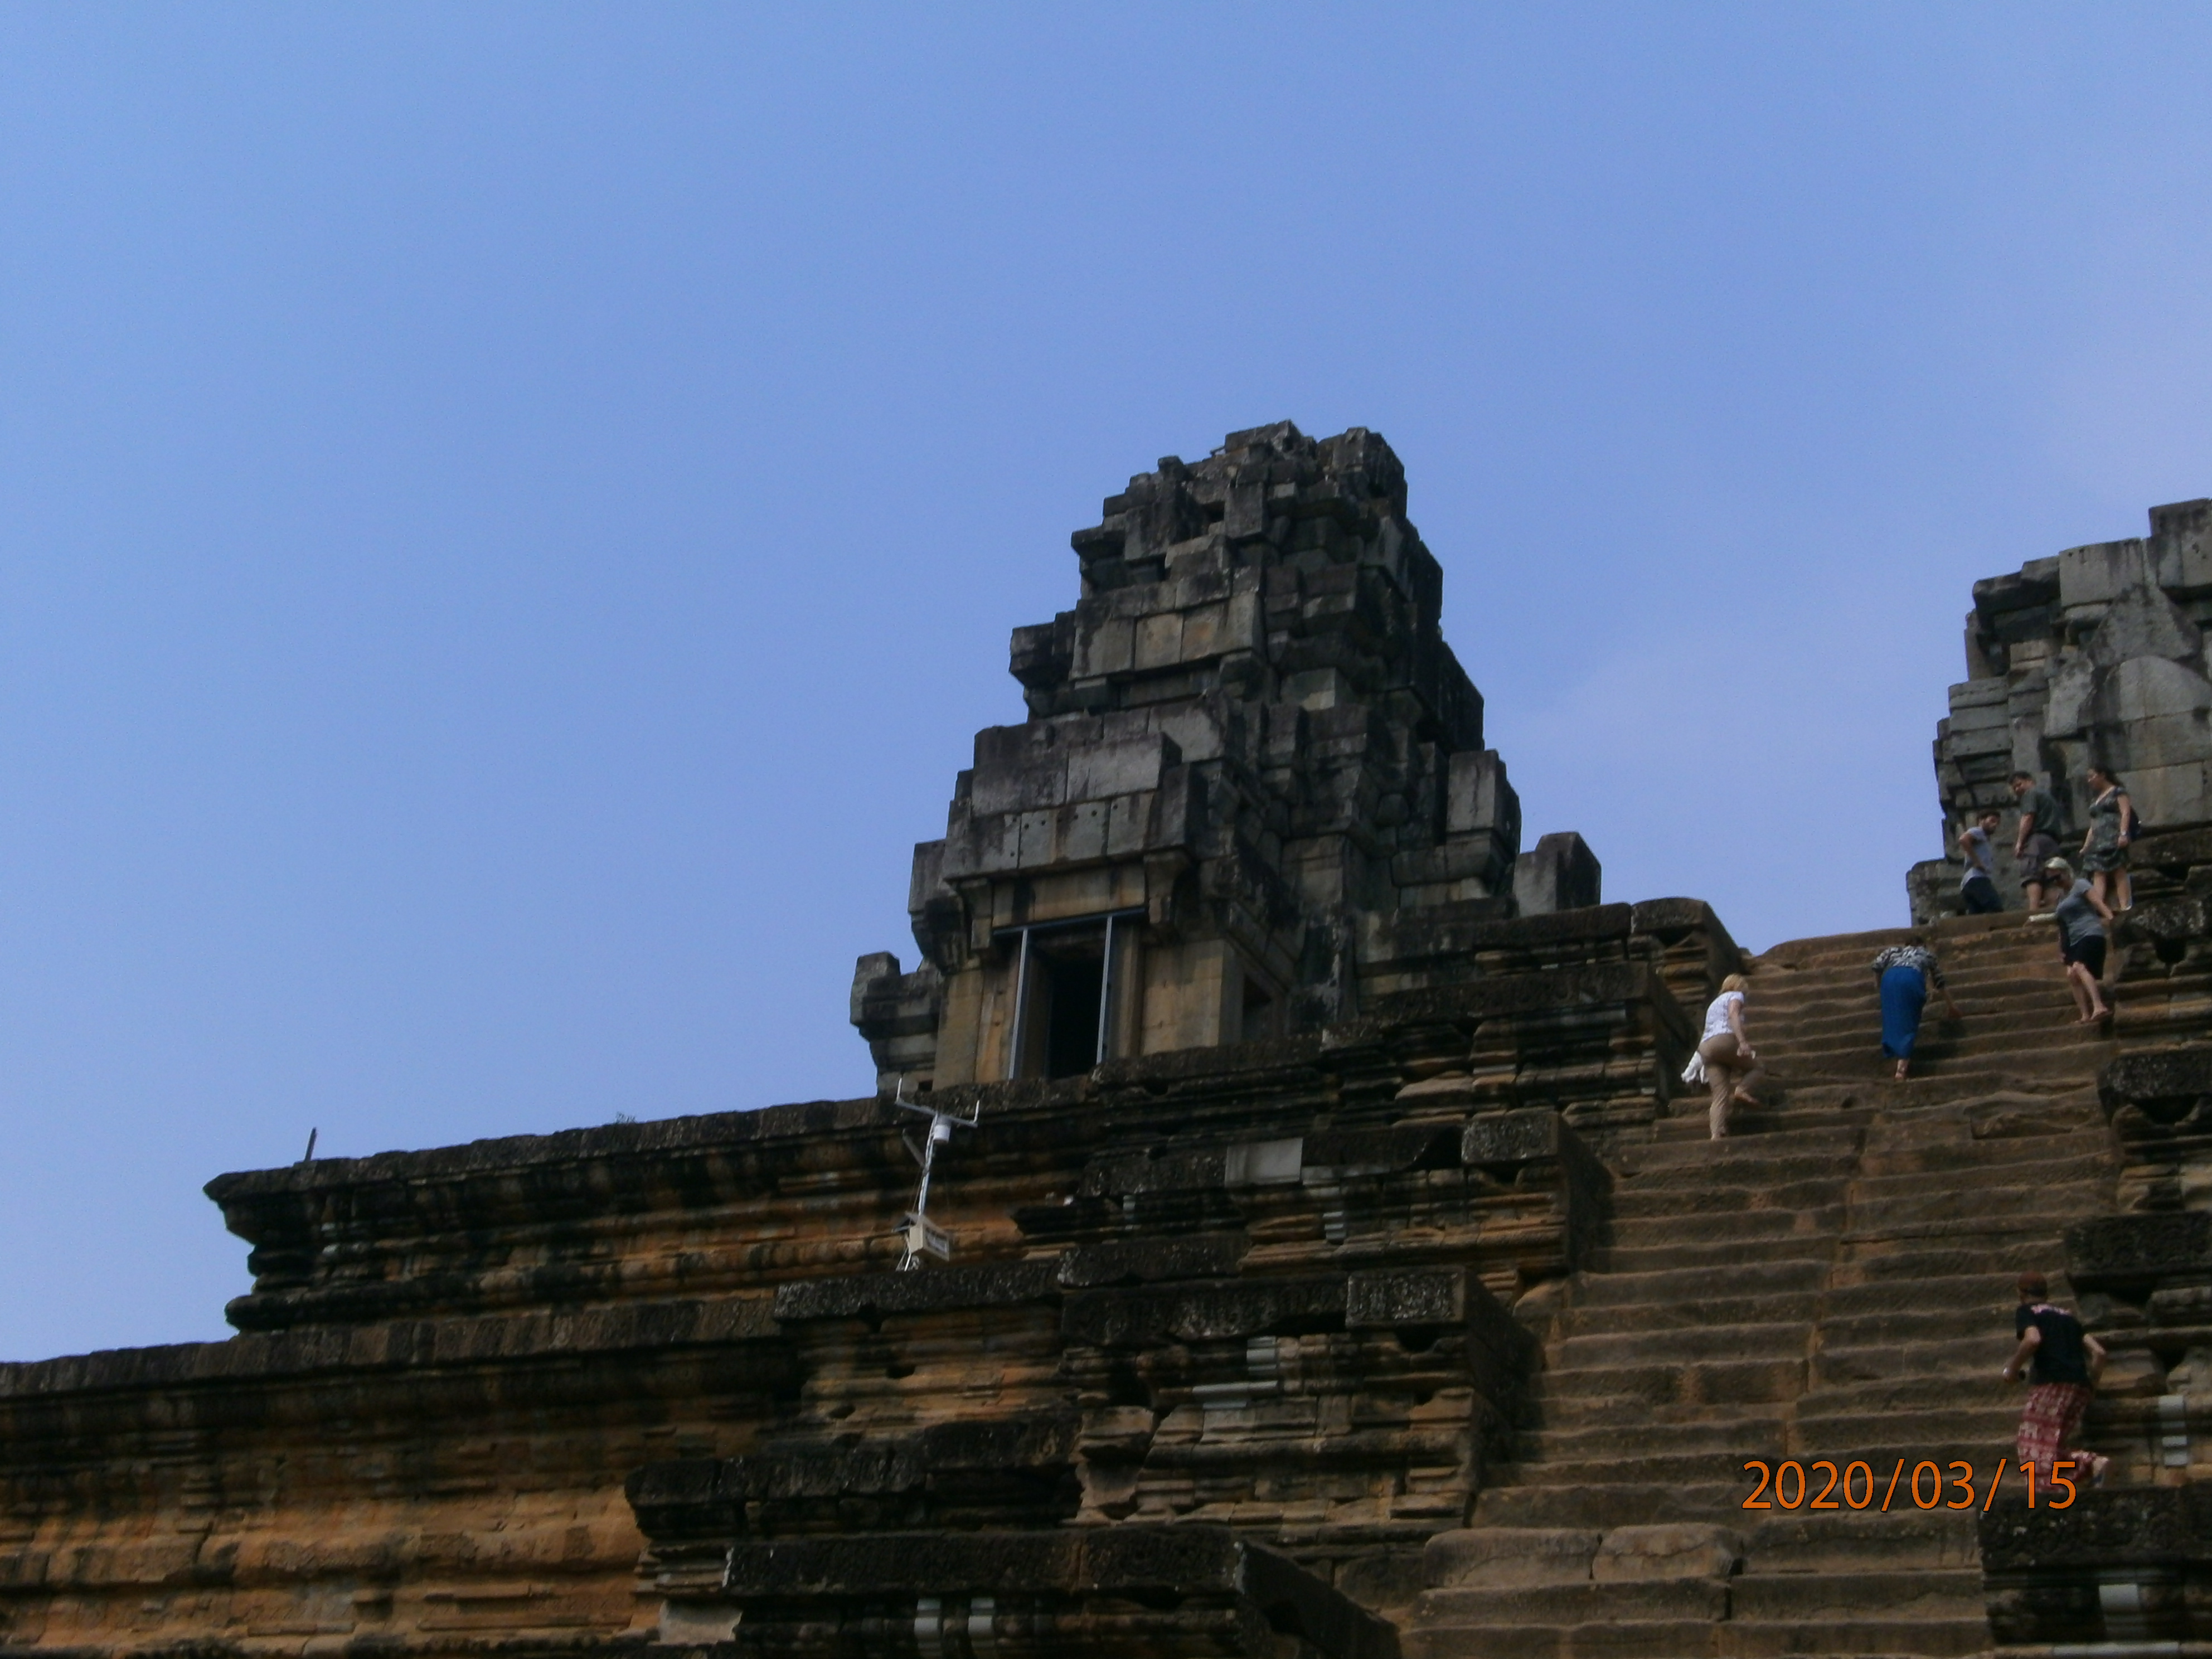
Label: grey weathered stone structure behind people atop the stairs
xmin=1907 ymin=500 xmax=2212 ymax=923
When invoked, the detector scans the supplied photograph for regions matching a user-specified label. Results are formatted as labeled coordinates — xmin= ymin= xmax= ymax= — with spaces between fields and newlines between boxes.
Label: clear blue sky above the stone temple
xmin=0 ymin=4 xmax=2212 ymax=1358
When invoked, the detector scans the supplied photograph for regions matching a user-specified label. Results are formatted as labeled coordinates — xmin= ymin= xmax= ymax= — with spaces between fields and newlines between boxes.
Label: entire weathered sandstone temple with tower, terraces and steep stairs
xmin=13 ymin=425 xmax=2212 ymax=1659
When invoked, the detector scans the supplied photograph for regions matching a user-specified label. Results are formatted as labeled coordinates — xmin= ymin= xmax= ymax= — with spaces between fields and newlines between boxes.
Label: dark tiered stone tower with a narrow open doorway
xmin=852 ymin=423 xmax=1599 ymax=1090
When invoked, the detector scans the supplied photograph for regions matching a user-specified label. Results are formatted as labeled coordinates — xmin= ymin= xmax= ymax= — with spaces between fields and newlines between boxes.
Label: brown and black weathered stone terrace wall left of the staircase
xmin=0 ymin=900 xmax=1707 ymax=1659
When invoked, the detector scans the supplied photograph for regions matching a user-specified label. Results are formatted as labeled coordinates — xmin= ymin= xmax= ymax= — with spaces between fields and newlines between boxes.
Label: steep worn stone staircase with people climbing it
xmin=1400 ymin=914 xmax=2117 ymax=1659
